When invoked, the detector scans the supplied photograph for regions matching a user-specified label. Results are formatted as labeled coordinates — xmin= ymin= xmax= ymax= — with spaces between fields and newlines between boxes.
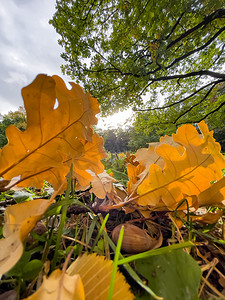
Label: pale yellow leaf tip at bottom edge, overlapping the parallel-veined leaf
xmin=26 ymin=269 xmax=85 ymax=300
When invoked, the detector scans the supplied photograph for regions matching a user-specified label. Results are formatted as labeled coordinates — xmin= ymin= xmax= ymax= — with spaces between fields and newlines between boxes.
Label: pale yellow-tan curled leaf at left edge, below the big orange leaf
xmin=0 ymin=199 xmax=53 ymax=274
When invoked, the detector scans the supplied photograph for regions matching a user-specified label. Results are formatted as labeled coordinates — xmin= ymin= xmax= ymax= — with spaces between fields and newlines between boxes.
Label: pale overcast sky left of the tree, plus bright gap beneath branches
xmin=0 ymin=0 xmax=133 ymax=127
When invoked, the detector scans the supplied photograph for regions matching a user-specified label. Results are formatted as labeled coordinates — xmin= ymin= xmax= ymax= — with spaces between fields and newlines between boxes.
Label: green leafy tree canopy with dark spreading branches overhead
xmin=50 ymin=0 xmax=225 ymax=126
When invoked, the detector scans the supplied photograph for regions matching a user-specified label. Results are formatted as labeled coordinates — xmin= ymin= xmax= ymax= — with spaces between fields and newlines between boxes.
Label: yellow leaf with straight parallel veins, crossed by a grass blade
xmin=67 ymin=253 xmax=134 ymax=300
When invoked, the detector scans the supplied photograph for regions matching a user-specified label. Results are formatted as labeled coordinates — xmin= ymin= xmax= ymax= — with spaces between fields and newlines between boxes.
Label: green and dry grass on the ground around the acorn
xmin=0 ymin=155 xmax=225 ymax=300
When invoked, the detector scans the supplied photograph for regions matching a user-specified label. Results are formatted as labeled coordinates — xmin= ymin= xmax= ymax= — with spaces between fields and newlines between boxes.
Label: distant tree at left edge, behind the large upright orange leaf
xmin=0 ymin=106 xmax=27 ymax=148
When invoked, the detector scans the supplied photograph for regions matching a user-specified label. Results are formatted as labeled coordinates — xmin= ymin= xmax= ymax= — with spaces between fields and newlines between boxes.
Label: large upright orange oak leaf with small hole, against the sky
xmin=0 ymin=75 xmax=105 ymax=189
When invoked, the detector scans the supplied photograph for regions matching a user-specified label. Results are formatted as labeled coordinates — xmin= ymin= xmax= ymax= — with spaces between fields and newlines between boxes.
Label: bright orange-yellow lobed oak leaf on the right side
xmin=136 ymin=121 xmax=225 ymax=209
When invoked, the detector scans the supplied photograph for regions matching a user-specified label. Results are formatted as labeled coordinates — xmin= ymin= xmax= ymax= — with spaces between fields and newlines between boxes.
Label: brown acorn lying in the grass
xmin=112 ymin=223 xmax=162 ymax=254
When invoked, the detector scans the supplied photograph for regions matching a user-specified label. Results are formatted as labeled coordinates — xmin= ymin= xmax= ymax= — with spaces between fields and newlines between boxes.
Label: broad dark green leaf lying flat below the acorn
xmin=135 ymin=249 xmax=201 ymax=300
